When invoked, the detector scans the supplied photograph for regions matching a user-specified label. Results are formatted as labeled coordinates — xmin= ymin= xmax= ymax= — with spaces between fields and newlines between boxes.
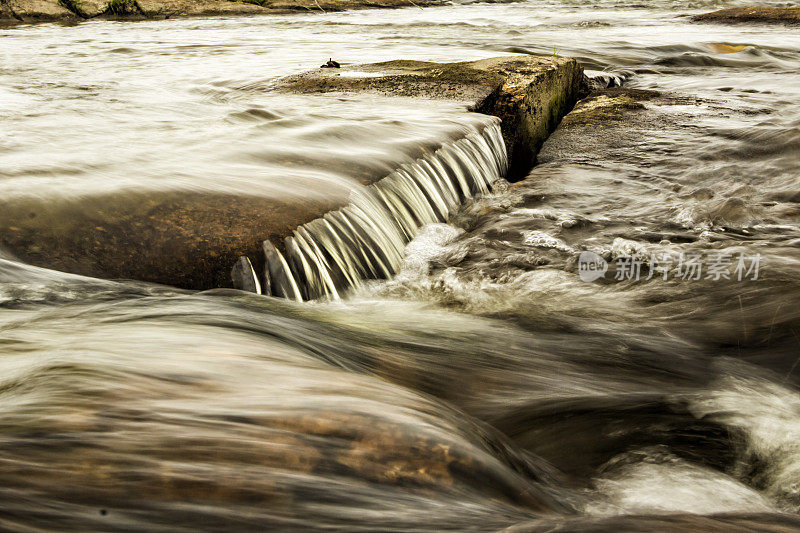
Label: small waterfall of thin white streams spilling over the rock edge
xmin=231 ymin=120 xmax=508 ymax=301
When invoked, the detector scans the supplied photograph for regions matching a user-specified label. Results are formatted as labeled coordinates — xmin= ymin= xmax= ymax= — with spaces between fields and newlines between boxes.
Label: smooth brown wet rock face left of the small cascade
xmin=0 ymin=189 xmax=347 ymax=289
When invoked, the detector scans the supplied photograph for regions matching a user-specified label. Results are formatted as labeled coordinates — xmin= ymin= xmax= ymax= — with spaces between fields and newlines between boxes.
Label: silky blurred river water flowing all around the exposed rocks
xmin=0 ymin=0 xmax=800 ymax=531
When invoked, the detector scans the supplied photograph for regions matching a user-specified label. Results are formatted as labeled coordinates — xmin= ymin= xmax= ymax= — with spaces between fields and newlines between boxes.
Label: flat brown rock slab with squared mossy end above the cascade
xmin=277 ymin=55 xmax=583 ymax=179
